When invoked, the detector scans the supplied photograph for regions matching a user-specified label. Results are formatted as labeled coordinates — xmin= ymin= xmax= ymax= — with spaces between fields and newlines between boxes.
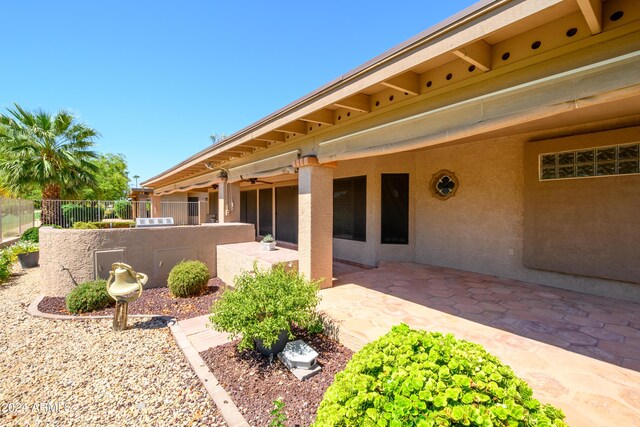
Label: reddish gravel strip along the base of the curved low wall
xmin=38 ymin=277 xmax=226 ymax=320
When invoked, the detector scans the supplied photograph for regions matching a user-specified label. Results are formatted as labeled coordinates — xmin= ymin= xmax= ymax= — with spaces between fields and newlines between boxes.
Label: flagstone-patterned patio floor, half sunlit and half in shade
xmin=320 ymin=263 xmax=640 ymax=426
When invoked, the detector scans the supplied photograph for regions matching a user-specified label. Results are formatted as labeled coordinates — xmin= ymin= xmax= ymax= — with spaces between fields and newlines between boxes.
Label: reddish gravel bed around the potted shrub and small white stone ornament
xmin=200 ymin=331 xmax=353 ymax=426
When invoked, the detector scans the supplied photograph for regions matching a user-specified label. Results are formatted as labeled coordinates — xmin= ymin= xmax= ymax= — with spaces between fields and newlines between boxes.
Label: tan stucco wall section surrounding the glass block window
xmin=524 ymin=127 xmax=640 ymax=284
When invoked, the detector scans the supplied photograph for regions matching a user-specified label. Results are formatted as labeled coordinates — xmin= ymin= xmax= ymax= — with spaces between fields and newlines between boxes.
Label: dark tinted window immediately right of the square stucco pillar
xmin=333 ymin=176 xmax=367 ymax=242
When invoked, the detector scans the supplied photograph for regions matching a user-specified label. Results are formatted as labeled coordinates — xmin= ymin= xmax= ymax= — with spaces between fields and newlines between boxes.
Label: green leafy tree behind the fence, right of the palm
xmin=78 ymin=153 xmax=129 ymax=200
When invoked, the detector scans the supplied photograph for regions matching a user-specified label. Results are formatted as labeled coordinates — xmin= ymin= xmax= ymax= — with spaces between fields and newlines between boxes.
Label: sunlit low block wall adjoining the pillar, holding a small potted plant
xmin=217 ymin=242 xmax=298 ymax=285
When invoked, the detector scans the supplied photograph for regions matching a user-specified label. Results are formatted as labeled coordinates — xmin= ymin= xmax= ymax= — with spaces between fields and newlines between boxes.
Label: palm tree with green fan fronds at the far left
xmin=0 ymin=104 xmax=99 ymax=224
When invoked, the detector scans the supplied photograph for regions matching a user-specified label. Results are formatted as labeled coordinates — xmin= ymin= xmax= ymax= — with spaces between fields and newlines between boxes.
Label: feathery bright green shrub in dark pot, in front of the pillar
xmin=209 ymin=265 xmax=319 ymax=350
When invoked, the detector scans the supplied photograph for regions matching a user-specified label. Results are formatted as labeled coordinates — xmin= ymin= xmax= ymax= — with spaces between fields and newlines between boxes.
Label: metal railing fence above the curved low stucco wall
xmin=41 ymin=200 xmax=203 ymax=228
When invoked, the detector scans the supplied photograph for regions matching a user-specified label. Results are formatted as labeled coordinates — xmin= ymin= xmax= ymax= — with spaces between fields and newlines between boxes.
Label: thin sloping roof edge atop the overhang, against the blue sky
xmin=141 ymin=0 xmax=513 ymax=185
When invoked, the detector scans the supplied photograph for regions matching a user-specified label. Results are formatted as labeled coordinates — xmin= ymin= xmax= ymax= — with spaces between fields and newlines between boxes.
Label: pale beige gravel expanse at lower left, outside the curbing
xmin=0 ymin=268 xmax=224 ymax=426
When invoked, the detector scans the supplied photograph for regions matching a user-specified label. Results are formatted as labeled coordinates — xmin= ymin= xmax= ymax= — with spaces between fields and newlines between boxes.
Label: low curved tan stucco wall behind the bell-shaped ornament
xmin=40 ymin=223 xmax=254 ymax=296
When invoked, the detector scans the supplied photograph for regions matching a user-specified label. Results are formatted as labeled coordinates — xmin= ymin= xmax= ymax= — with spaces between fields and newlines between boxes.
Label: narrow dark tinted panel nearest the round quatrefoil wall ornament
xmin=381 ymin=174 xmax=409 ymax=244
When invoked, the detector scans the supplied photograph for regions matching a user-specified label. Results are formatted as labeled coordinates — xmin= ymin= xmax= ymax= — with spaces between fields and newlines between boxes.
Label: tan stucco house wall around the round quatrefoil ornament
xmin=333 ymin=136 xmax=640 ymax=301
